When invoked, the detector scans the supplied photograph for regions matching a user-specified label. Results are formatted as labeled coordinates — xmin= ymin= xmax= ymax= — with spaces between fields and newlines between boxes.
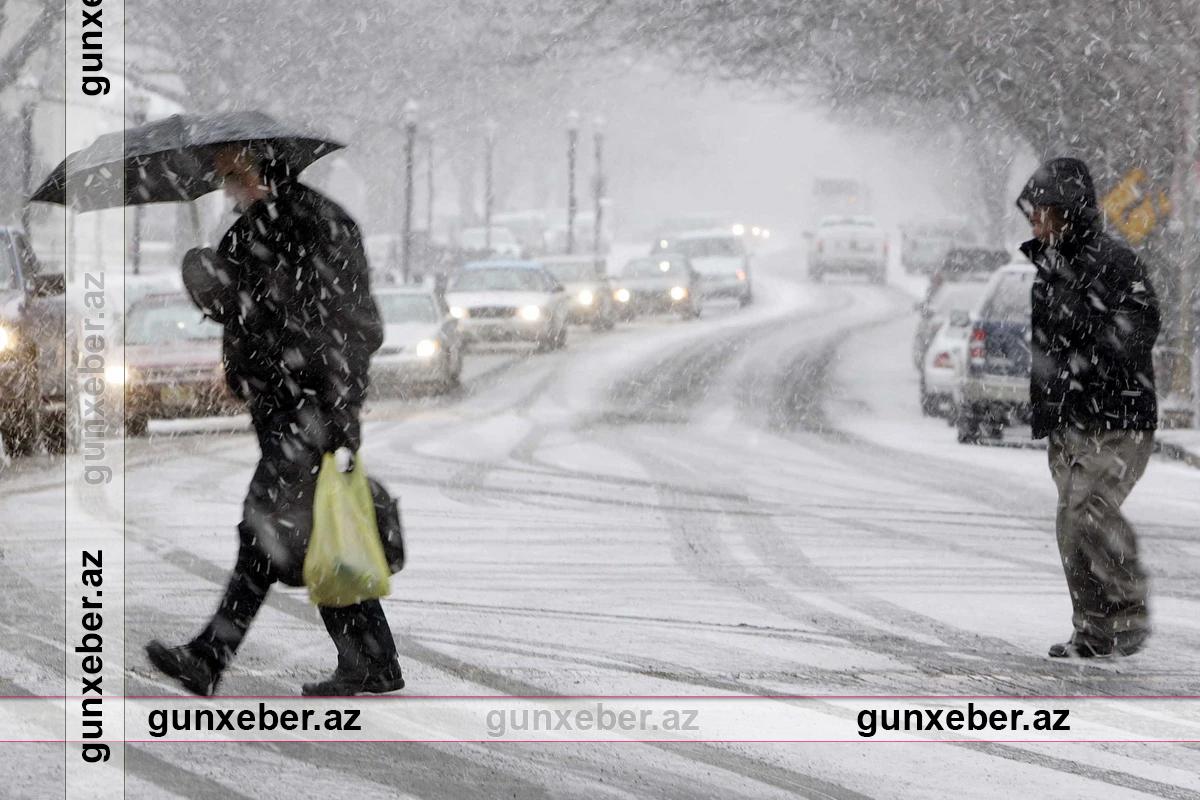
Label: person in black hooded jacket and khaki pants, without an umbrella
xmin=1018 ymin=158 xmax=1160 ymax=658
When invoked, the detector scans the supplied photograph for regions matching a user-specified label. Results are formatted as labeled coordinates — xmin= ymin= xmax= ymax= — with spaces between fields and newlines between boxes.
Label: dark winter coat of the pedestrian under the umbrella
xmin=184 ymin=181 xmax=383 ymax=452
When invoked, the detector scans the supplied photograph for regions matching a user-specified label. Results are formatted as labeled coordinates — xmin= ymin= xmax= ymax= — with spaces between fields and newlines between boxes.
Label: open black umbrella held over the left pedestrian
xmin=29 ymin=112 xmax=344 ymax=211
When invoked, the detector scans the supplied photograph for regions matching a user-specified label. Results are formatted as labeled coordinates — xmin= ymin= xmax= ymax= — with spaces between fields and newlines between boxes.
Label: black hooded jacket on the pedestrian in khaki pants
xmin=1018 ymin=158 xmax=1159 ymax=438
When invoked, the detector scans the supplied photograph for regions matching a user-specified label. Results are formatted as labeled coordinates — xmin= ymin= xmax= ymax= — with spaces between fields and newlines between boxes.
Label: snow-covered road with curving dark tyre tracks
xmin=0 ymin=252 xmax=1200 ymax=800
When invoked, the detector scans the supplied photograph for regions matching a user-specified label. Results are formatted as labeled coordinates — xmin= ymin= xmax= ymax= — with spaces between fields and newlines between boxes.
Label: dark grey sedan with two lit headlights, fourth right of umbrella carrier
xmin=613 ymin=253 xmax=704 ymax=320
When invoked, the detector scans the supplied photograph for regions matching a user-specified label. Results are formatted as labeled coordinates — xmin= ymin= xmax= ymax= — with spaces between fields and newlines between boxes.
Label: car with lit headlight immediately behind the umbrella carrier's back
xmin=371 ymin=288 xmax=462 ymax=393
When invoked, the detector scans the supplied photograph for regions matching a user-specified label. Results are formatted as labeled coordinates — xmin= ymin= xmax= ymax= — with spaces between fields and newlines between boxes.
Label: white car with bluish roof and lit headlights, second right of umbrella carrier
xmin=445 ymin=259 xmax=571 ymax=350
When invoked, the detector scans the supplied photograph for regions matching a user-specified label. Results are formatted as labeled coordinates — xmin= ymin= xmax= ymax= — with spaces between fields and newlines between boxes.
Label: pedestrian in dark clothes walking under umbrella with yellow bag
xmin=146 ymin=145 xmax=404 ymax=696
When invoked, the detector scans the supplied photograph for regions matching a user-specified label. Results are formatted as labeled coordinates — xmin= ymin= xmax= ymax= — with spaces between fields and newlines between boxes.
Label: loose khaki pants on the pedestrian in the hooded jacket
xmin=1049 ymin=429 xmax=1154 ymax=642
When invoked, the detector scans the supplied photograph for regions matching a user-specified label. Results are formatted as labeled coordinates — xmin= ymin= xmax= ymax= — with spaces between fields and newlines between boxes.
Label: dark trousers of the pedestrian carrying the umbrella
xmin=191 ymin=407 xmax=396 ymax=672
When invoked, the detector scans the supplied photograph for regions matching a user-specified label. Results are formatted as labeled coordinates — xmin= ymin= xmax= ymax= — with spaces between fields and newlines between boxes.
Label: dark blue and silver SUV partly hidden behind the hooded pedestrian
xmin=954 ymin=264 xmax=1036 ymax=443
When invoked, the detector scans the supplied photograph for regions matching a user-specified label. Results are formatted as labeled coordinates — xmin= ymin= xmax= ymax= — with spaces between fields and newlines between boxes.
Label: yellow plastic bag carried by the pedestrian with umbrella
xmin=304 ymin=453 xmax=391 ymax=607
